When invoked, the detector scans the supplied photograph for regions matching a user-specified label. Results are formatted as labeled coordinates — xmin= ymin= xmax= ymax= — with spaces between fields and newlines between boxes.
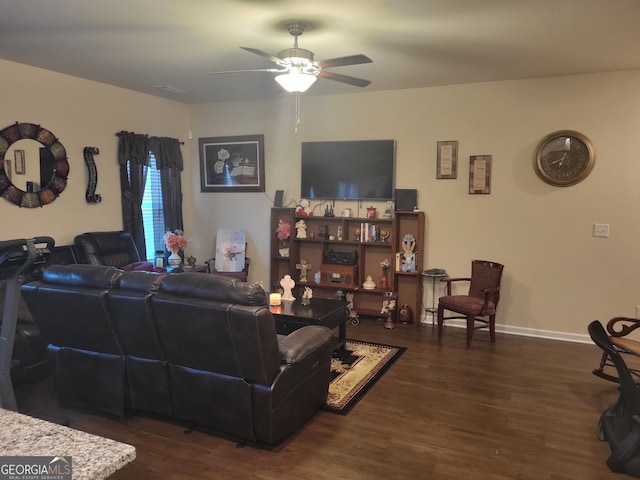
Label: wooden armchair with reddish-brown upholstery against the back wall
xmin=438 ymin=260 xmax=504 ymax=348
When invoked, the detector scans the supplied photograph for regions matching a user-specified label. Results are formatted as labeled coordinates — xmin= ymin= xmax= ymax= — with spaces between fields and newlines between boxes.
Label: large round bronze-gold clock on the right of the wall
xmin=533 ymin=130 xmax=596 ymax=187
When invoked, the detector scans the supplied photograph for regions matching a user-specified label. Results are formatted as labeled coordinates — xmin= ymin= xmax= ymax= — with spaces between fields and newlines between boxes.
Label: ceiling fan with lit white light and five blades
xmin=209 ymin=22 xmax=372 ymax=93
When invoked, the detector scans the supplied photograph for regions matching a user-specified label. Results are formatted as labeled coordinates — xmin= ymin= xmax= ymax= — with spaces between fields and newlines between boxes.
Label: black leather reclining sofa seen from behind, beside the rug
xmin=22 ymin=264 xmax=331 ymax=444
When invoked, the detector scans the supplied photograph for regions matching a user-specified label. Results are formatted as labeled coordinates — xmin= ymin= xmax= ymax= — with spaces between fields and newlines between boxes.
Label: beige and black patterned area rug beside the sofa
xmin=324 ymin=340 xmax=406 ymax=415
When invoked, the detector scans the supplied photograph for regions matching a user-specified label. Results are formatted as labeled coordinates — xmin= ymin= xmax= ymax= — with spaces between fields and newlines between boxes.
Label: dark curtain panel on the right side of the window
xmin=149 ymin=137 xmax=184 ymax=230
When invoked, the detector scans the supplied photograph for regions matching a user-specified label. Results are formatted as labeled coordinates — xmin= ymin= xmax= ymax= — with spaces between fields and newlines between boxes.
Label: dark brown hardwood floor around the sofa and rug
xmin=16 ymin=320 xmax=629 ymax=480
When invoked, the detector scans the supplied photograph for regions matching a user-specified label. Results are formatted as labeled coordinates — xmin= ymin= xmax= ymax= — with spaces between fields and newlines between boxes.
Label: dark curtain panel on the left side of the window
xmin=117 ymin=131 xmax=149 ymax=256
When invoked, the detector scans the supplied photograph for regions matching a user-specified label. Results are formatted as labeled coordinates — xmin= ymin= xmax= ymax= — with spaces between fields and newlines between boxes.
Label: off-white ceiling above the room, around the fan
xmin=0 ymin=0 xmax=640 ymax=104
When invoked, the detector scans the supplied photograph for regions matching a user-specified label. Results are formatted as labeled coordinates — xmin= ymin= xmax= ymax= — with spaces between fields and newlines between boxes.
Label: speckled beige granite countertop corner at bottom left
xmin=0 ymin=408 xmax=136 ymax=480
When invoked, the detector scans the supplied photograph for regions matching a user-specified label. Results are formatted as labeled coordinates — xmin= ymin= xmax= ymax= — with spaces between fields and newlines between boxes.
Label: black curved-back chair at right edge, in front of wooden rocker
xmin=588 ymin=320 xmax=640 ymax=477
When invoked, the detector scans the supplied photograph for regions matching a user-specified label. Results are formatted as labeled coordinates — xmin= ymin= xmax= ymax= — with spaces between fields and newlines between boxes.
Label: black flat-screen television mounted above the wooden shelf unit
xmin=300 ymin=140 xmax=396 ymax=200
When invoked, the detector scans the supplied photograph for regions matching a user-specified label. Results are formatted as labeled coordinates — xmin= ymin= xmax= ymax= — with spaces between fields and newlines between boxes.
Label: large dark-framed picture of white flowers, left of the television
xmin=198 ymin=135 xmax=265 ymax=192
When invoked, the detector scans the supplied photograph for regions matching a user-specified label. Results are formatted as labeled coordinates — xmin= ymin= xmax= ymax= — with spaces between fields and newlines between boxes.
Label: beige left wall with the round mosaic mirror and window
xmin=0 ymin=60 xmax=191 ymax=245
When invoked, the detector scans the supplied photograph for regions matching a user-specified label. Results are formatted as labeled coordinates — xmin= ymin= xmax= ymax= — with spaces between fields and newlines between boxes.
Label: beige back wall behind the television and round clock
xmin=192 ymin=71 xmax=640 ymax=340
